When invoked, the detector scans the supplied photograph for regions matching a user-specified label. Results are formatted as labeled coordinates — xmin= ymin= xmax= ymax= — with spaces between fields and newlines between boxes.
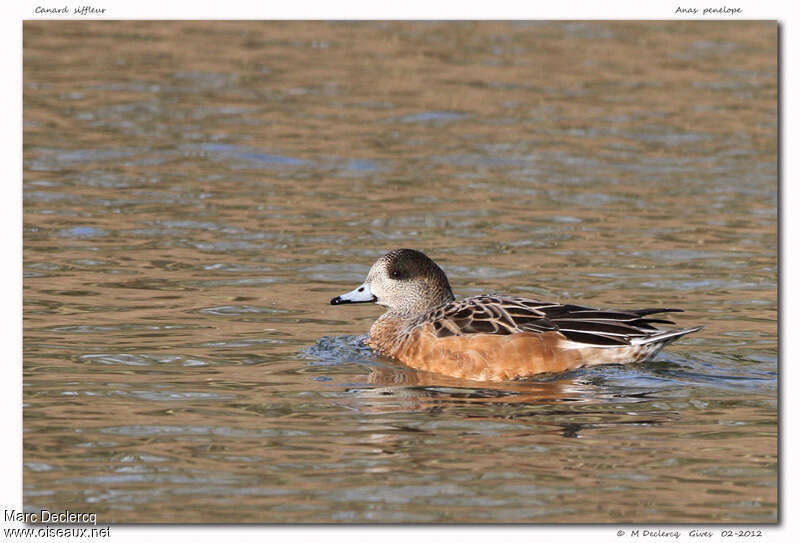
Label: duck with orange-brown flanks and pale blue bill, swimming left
xmin=330 ymin=249 xmax=702 ymax=381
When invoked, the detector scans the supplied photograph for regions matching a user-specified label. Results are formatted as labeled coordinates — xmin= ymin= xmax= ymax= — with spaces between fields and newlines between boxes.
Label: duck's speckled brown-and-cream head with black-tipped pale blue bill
xmin=331 ymin=249 xmax=454 ymax=317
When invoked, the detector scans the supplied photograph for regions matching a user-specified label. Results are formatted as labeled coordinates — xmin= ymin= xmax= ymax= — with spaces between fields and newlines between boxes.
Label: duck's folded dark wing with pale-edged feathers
xmin=424 ymin=296 xmax=681 ymax=345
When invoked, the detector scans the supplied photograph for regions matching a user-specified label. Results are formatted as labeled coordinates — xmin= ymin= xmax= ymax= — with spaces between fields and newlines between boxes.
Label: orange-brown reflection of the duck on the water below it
xmin=334 ymin=365 xmax=677 ymax=438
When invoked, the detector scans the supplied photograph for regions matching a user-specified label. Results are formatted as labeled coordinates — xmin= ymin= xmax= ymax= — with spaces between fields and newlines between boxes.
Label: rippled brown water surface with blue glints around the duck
xmin=23 ymin=21 xmax=777 ymax=523
